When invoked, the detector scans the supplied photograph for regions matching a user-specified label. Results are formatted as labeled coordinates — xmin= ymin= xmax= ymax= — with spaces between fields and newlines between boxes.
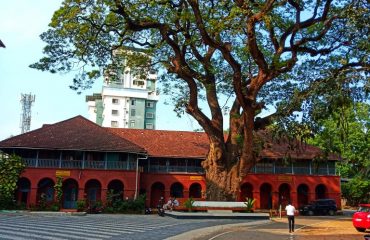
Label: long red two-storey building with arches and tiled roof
xmin=0 ymin=116 xmax=340 ymax=209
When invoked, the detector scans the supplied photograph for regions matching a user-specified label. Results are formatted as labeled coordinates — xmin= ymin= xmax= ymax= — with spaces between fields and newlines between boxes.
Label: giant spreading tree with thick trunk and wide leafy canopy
xmin=31 ymin=0 xmax=369 ymax=199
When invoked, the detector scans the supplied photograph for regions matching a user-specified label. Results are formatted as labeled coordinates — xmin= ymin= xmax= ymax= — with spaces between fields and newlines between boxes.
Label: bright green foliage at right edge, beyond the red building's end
xmin=309 ymin=103 xmax=370 ymax=178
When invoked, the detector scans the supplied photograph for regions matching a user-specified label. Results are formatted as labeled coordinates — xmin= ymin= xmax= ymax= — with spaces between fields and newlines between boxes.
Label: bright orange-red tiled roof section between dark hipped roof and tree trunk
xmin=108 ymin=128 xmax=209 ymax=159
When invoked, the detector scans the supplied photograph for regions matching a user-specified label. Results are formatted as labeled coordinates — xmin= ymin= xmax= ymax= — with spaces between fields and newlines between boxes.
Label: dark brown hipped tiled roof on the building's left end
xmin=0 ymin=116 xmax=145 ymax=153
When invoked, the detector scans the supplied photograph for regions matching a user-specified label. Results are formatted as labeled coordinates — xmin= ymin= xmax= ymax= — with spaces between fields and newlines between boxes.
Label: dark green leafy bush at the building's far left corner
xmin=0 ymin=152 xmax=26 ymax=209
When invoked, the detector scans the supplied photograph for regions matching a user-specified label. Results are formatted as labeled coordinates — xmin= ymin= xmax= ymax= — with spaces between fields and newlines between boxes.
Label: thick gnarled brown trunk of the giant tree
xmin=203 ymin=105 xmax=255 ymax=201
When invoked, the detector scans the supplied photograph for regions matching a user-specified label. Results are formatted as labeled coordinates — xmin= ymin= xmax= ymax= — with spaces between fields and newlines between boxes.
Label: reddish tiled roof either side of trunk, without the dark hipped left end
xmin=108 ymin=128 xmax=338 ymax=160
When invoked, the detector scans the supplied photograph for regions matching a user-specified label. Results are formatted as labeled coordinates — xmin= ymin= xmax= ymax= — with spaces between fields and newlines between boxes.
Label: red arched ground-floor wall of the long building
xmin=21 ymin=168 xmax=341 ymax=209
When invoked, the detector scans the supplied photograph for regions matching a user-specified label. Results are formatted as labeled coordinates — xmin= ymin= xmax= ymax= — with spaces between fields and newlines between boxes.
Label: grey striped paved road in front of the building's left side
xmin=0 ymin=214 xmax=250 ymax=240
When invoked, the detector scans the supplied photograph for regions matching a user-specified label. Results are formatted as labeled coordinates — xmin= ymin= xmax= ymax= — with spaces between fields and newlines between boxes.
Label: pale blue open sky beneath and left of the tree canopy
xmin=0 ymin=0 xmax=208 ymax=141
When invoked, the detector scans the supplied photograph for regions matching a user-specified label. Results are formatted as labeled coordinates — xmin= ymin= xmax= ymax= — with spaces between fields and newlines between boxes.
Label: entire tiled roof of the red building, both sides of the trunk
xmin=0 ymin=116 xmax=338 ymax=160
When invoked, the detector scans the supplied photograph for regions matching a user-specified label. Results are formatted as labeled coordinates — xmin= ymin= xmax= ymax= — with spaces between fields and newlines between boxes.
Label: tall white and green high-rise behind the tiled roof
xmin=86 ymin=52 xmax=159 ymax=129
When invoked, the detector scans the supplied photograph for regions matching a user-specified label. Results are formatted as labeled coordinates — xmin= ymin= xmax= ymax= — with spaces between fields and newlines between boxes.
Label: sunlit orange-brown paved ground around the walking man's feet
xmin=184 ymin=216 xmax=364 ymax=240
